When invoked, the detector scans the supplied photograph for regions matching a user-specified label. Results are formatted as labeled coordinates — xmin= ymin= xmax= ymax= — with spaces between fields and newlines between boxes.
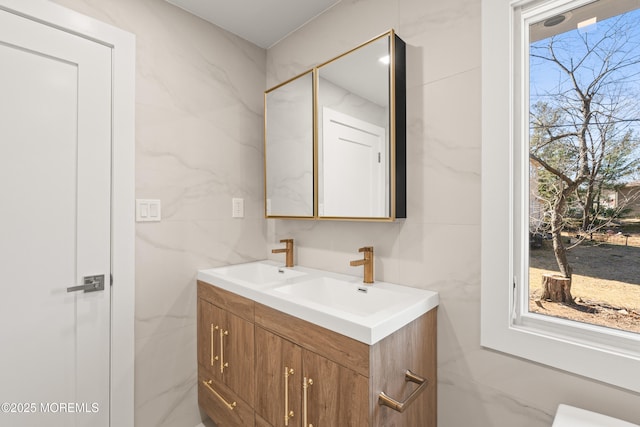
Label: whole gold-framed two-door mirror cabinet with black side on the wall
xmin=265 ymin=30 xmax=406 ymax=221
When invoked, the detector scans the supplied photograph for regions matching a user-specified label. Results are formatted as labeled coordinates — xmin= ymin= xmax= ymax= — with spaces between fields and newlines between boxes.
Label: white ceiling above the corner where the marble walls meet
xmin=167 ymin=0 xmax=340 ymax=49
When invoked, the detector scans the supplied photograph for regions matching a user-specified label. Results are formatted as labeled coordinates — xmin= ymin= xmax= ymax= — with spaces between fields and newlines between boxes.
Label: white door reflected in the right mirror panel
xmin=318 ymin=107 xmax=389 ymax=217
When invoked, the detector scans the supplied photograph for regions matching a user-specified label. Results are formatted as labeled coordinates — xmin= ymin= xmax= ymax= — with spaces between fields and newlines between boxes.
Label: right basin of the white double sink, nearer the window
xmin=273 ymin=277 xmax=411 ymax=317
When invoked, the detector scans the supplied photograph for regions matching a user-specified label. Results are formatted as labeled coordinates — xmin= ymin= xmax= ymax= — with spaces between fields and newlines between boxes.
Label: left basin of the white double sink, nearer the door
xmin=203 ymin=262 xmax=307 ymax=288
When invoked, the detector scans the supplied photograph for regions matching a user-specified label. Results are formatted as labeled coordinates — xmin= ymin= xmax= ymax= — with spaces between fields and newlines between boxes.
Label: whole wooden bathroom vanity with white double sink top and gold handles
xmin=197 ymin=261 xmax=438 ymax=427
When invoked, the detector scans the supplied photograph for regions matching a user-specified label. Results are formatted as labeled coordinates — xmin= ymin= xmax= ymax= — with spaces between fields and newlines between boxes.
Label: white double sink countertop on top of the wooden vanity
xmin=198 ymin=261 xmax=439 ymax=345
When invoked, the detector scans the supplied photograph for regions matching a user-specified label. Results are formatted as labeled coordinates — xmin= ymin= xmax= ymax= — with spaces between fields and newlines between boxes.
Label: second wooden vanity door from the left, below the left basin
xmin=220 ymin=312 xmax=255 ymax=406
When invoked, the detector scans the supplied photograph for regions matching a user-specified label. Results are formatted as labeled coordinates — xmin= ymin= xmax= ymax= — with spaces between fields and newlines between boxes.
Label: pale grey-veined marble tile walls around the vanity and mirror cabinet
xmin=48 ymin=0 xmax=638 ymax=427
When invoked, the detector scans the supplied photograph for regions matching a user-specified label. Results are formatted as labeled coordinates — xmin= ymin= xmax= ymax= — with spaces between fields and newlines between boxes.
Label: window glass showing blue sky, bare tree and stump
xmin=524 ymin=0 xmax=640 ymax=333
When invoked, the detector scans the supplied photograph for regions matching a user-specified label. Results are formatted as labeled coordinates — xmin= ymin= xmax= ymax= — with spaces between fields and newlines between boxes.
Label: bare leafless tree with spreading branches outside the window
xmin=529 ymin=15 xmax=640 ymax=288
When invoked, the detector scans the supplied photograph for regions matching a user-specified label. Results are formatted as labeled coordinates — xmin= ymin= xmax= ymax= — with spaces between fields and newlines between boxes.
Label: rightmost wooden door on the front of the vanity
xmin=302 ymin=350 xmax=369 ymax=427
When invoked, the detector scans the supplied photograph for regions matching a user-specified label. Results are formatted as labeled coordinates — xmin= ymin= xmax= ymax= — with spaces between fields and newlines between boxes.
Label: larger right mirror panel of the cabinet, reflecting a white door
xmin=317 ymin=32 xmax=404 ymax=219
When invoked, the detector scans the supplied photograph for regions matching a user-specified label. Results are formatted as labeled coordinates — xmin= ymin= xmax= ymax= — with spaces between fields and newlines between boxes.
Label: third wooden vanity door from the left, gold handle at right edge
xmin=255 ymin=327 xmax=302 ymax=427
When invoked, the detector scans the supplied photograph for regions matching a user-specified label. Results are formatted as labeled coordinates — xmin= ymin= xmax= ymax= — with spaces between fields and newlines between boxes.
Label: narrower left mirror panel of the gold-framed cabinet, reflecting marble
xmin=265 ymin=71 xmax=314 ymax=217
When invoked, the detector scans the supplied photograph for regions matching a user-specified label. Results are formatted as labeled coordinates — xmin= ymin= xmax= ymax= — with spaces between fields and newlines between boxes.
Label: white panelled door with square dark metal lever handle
xmin=0 ymin=11 xmax=111 ymax=427
